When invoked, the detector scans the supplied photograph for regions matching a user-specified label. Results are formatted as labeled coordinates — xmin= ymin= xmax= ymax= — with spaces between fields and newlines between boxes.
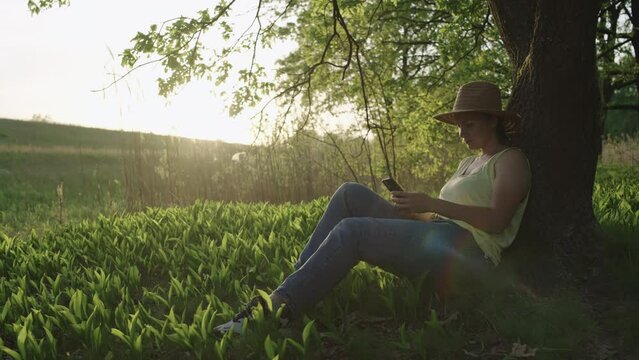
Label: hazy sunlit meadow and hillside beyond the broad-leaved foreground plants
xmin=0 ymin=119 xmax=371 ymax=235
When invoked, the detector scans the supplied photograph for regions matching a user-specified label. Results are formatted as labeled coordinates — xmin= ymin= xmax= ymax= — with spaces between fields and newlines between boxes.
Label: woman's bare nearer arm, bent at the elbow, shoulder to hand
xmin=392 ymin=151 xmax=530 ymax=233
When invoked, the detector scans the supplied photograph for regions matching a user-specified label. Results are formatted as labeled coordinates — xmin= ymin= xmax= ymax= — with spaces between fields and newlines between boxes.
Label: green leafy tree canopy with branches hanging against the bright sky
xmin=28 ymin=0 xmax=639 ymax=167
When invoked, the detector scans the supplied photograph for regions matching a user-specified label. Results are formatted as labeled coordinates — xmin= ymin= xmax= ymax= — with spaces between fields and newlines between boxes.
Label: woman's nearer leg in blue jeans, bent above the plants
xmin=274 ymin=217 xmax=488 ymax=313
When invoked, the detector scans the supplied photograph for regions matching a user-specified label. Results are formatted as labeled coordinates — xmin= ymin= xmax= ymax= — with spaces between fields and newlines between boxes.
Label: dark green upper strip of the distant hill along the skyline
xmin=0 ymin=119 xmax=239 ymax=149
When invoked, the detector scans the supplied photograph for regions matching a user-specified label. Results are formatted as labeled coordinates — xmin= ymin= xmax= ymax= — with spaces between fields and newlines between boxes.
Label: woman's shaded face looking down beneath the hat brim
xmin=455 ymin=113 xmax=498 ymax=149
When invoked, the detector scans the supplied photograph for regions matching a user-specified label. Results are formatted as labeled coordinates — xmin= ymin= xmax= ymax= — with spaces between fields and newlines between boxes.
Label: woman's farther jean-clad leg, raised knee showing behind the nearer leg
xmin=295 ymin=182 xmax=401 ymax=270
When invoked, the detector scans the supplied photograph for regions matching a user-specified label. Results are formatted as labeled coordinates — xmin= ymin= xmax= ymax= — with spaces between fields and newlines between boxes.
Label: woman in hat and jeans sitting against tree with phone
xmin=216 ymin=81 xmax=531 ymax=332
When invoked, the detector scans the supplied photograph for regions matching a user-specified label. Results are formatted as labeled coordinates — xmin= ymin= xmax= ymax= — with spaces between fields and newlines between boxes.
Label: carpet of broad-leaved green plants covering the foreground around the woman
xmin=0 ymin=199 xmax=608 ymax=359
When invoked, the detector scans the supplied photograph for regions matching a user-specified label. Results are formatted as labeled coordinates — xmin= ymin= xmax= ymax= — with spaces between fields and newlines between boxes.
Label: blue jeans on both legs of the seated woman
xmin=275 ymin=183 xmax=489 ymax=313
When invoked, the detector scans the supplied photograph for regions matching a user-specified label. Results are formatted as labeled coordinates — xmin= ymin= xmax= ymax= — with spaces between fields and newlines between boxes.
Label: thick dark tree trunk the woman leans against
xmin=490 ymin=0 xmax=602 ymax=272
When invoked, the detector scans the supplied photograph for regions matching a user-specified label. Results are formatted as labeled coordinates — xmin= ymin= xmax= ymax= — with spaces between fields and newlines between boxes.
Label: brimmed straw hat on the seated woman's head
xmin=434 ymin=81 xmax=521 ymax=134
